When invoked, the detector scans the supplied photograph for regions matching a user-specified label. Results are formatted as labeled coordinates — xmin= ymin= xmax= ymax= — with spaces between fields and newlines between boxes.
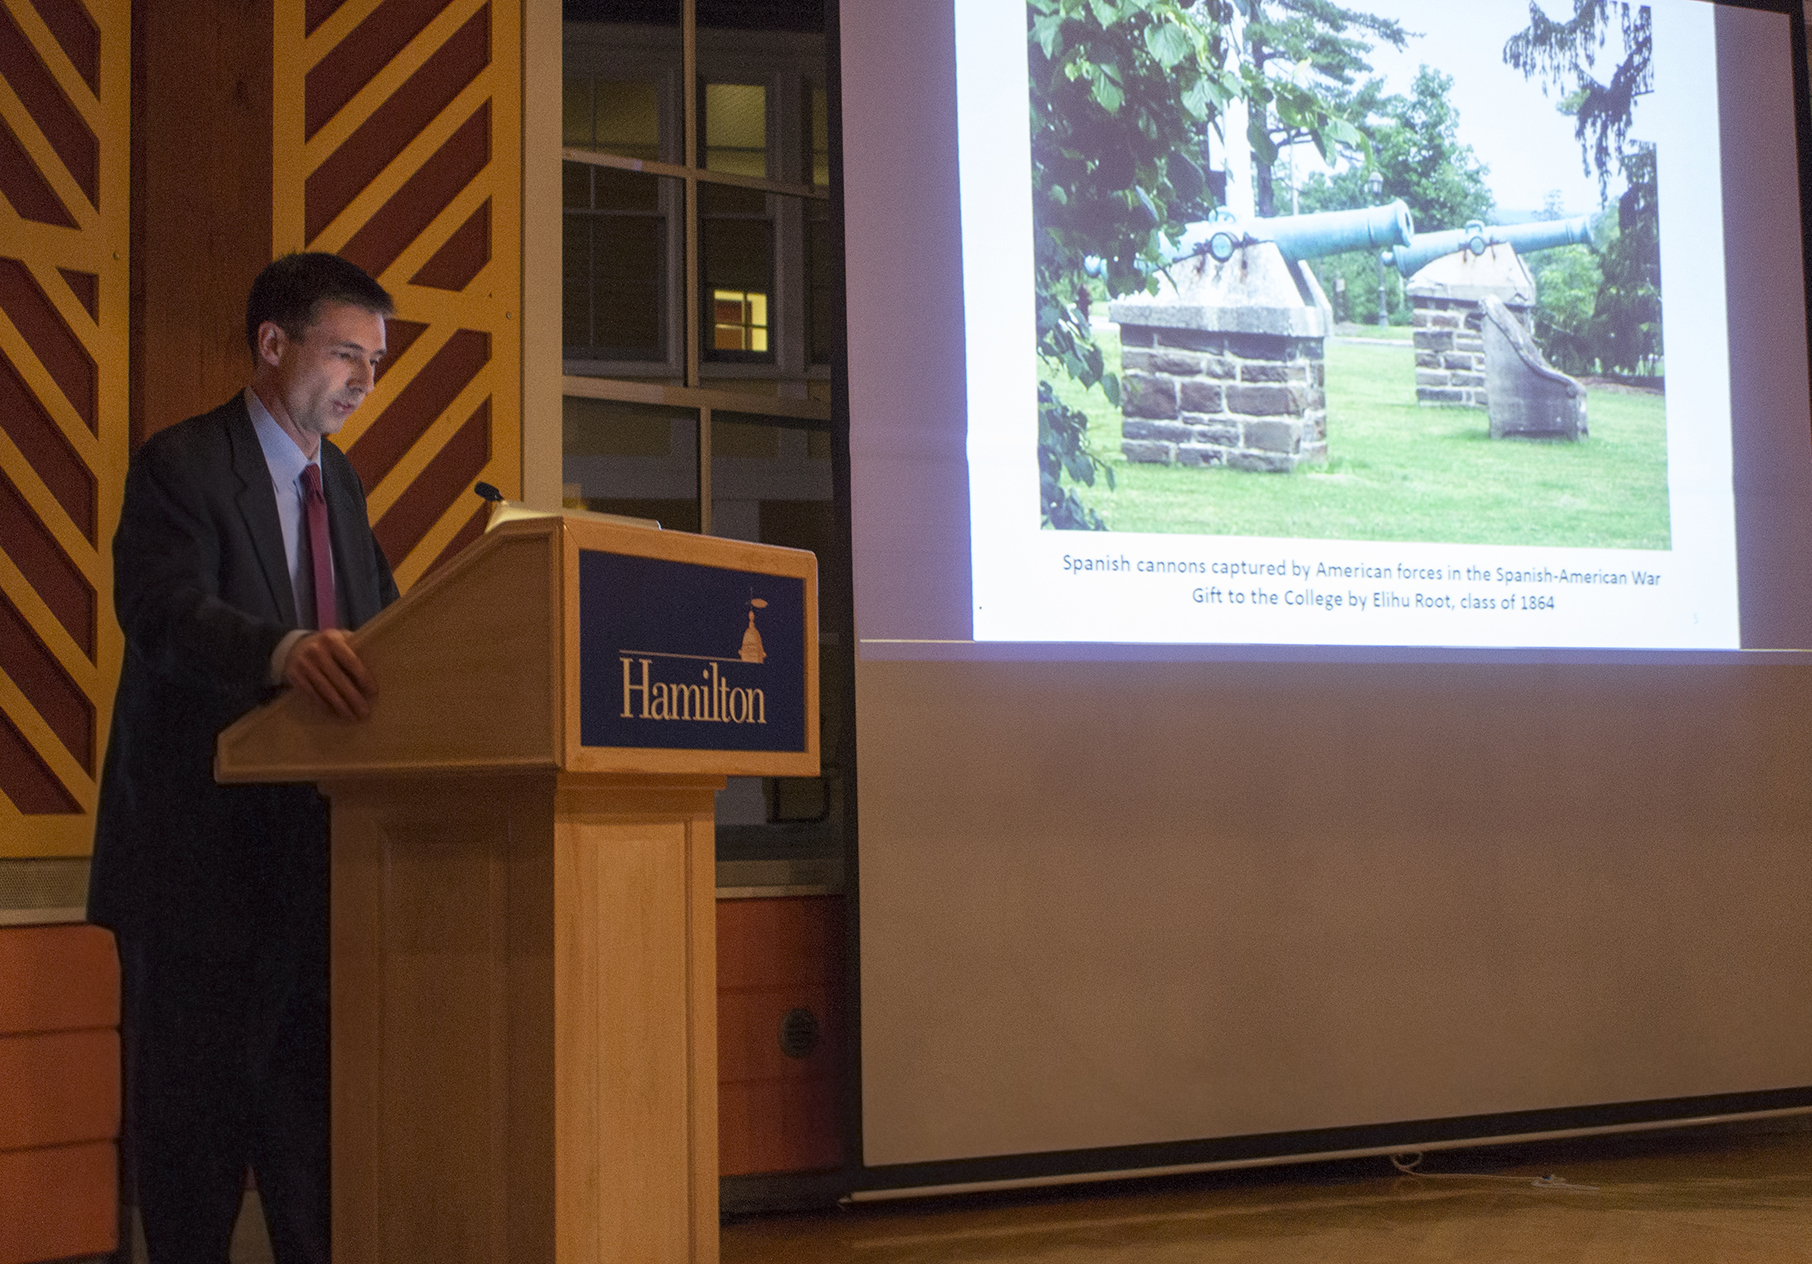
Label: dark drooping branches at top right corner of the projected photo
xmin=1504 ymin=0 xmax=1654 ymax=196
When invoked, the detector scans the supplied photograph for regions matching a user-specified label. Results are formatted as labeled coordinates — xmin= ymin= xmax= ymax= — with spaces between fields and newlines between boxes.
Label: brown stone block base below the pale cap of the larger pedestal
xmin=1120 ymin=324 xmax=1333 ymax=473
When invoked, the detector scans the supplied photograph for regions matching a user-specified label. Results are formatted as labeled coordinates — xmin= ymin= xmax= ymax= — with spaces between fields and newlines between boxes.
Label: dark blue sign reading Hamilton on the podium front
xmin=578 ymin=549 xmax=806 ymax=753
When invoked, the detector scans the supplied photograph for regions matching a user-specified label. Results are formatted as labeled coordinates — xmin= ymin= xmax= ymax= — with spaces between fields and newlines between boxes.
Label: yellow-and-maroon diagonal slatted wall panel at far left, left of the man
xmin=0 ymin=0 xmax=132 ymax=857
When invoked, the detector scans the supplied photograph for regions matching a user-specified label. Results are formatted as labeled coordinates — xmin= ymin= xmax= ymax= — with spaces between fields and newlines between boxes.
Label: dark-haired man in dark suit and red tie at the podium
xmin=89 ymin=254 xmax=397 ymax=1264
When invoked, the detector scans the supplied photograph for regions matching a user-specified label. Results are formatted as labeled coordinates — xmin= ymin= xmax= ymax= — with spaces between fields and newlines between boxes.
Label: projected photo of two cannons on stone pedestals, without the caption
xmin=1027 ymin=0 xmax=1671 ymax=549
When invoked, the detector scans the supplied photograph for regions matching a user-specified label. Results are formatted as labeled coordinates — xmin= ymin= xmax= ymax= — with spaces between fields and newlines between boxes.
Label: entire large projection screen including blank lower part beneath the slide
xmin=841 ymin=0 xmax=1812 ymax=1192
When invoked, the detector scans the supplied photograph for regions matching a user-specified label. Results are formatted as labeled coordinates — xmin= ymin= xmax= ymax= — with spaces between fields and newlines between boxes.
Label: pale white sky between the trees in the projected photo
xmin=1297 ymin=0 xmax=1652 ymax=216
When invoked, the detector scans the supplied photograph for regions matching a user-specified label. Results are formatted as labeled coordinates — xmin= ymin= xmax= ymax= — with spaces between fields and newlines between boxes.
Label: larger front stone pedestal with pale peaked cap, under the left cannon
xmin=1109 ymin=241 xmax=1332 ymax=473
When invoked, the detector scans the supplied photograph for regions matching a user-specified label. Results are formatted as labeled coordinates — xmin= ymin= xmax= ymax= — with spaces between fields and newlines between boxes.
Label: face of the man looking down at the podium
xmin=257 ymin=302 xmax=384 ymax=453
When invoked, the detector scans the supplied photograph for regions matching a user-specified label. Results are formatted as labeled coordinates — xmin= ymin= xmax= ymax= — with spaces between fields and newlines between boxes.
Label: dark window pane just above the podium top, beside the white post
xmin=562 ymin=395 xmax=699 ymax=531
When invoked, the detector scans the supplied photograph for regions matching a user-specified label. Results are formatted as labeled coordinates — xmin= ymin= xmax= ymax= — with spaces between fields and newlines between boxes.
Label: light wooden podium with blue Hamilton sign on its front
xmin=216 ymin=516 xmax=819 ymax=1264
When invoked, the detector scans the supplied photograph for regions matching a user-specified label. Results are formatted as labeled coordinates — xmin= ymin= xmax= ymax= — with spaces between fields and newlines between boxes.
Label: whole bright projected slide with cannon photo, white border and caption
xmin=957 ymin=0 xmax=1740 ymax=648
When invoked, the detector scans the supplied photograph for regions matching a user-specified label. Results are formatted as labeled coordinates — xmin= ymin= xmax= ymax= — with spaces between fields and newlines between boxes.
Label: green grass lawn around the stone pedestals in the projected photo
xmin=1055 ymin=328 xmax=1671 ymax=549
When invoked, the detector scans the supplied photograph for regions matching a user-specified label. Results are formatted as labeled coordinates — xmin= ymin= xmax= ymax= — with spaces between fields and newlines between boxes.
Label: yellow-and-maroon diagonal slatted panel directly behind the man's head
xmin=272 ymin=0 xmax=522 ymax=589
